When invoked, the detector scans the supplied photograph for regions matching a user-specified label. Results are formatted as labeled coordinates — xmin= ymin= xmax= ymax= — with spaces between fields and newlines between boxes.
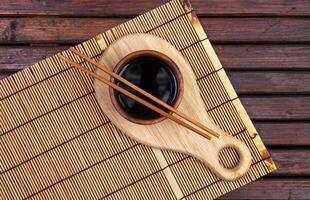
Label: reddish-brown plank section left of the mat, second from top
xmin=0 ymin=18 xmax=123 ymax=44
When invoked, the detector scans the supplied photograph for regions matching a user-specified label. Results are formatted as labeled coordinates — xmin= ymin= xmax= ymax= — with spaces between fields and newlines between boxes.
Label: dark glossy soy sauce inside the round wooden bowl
xmin=115 ymin=56 xmax=178 ymax=120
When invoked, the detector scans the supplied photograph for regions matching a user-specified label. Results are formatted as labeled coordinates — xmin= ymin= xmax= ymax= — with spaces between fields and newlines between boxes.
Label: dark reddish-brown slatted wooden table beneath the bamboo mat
xmin=0 ymin=0 xmax=310 ymax=199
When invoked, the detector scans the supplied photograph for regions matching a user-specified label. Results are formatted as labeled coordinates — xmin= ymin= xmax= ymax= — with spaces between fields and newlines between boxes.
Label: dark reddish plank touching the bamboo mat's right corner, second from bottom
xmin=268 ymin=148 xmax=310 ymax=176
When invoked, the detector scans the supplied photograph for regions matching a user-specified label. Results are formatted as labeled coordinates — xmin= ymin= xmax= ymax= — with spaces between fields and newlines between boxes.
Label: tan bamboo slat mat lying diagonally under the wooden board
xmin=0 ymin=0 xmax=276 ymax=200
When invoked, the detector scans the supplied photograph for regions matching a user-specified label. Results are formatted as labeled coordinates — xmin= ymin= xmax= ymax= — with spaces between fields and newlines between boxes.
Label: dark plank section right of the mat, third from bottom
xmin=254 ymin=122 xmax=310 ymax=146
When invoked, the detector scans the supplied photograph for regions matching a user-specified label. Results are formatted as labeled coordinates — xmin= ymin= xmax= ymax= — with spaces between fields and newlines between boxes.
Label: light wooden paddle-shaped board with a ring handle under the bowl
xmin=95 ymin=34 xmax=251 ymax=180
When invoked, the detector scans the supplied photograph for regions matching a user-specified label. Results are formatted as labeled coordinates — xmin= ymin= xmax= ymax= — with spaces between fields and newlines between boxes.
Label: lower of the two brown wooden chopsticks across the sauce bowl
xmin=59 ymin=55 xmax=211 ymax=139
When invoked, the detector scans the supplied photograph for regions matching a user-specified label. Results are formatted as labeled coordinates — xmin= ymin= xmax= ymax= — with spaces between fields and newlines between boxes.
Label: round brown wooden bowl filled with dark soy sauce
xmin=110 ymin=50 xmax=183 ymax=124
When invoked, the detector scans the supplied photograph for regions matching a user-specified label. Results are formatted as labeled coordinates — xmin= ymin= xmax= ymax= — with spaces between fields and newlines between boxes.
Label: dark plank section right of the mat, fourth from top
xmin=228 ymin=71 xmax=310 ymax=94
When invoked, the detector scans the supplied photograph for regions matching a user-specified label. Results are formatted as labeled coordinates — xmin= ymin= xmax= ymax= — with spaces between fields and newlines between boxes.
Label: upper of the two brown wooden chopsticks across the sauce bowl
xmin=69 ymin=47 xmax=220 ymax=137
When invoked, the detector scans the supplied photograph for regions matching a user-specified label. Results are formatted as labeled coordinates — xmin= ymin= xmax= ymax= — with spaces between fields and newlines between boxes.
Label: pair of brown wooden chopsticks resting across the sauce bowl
xmin=59 ymin=47 xmax=220 ymax=139
